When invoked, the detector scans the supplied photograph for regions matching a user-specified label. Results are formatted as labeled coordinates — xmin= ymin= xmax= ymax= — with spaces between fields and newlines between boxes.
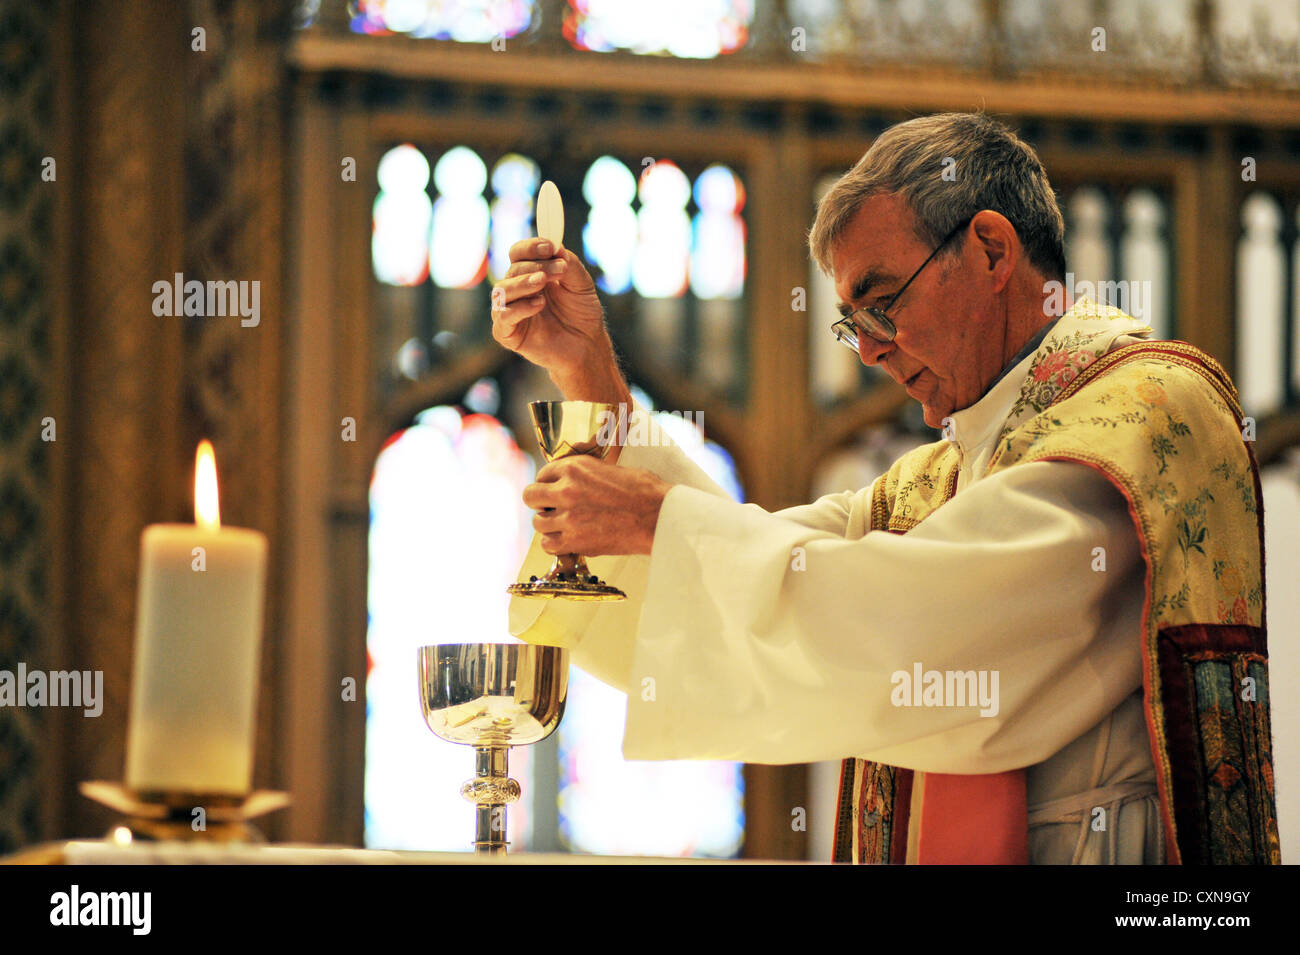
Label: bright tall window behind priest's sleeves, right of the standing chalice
xmin=558 ymin=388 xmax=745 ymax=858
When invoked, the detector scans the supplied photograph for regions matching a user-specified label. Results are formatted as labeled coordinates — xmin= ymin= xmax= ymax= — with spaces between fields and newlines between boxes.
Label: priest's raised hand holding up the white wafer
xmin=491 ymin=238 xmax=631 ymax=403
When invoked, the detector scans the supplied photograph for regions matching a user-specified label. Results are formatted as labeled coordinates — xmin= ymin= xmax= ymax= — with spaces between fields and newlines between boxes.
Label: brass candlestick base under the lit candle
xmin=81 ymin=780 xmax=290 ymax=842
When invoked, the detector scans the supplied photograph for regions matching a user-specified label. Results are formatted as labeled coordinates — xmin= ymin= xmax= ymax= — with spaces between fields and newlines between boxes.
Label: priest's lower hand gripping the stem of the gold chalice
xmin=524 ymin=455 xmax=672 ymax=557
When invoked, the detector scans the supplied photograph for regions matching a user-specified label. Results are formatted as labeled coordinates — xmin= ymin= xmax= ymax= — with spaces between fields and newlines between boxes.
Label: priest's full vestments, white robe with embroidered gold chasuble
xmin=511 ymin=299 xmax=1279 ymax=863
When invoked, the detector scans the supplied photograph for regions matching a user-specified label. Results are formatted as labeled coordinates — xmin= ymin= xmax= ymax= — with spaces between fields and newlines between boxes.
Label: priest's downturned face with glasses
xmin=831 ymin=195 xmax=1006 ymax=427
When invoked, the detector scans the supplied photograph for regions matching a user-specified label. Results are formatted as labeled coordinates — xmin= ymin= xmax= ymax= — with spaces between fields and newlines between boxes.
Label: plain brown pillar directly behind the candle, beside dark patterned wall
xmin=59 ymin=0 xmax=194 ymax=837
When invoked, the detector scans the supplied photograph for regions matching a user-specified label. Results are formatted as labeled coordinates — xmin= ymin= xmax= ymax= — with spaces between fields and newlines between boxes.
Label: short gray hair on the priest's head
xmin=809 ymin=113 xmax=1065 ymax=281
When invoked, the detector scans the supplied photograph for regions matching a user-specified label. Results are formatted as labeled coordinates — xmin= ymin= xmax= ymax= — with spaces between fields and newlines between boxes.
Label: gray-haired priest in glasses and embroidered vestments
xmin=493 ymin=113 xmax=1279 ymax=864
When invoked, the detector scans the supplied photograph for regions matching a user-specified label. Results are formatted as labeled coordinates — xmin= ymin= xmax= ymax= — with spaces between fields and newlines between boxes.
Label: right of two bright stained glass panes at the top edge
xmin=564 ymin=0 xmax=754 ymax=60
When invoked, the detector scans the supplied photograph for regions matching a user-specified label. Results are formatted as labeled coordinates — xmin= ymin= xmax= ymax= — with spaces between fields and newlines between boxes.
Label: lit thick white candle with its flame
xmin=126 ymin=442 xmax=267 ymax=795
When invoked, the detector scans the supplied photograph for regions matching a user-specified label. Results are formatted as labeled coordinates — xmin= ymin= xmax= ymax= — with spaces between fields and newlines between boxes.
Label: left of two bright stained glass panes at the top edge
xmin=351 ymin=0 xmax=533 ymax=43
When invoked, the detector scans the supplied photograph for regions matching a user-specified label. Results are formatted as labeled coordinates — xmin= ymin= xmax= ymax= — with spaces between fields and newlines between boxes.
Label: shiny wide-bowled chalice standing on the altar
xmin=420 ymin=643 xmax=569 ymax=855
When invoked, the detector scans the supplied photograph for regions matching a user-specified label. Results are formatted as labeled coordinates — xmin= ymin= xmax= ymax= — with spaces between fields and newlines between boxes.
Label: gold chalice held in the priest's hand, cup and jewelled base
xmin=510 ymin=401 xmax=627 ymax=600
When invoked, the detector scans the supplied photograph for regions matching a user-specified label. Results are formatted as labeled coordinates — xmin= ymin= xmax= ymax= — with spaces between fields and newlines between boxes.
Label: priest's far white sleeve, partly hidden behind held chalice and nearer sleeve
xmin=510 ymin=405 xmax=870 ymax=693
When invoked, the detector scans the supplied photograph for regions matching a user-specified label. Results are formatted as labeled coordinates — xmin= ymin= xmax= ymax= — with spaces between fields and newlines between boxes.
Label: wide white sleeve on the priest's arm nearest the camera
xmin=624 ymin=461 xmax=1144 ymax=773
